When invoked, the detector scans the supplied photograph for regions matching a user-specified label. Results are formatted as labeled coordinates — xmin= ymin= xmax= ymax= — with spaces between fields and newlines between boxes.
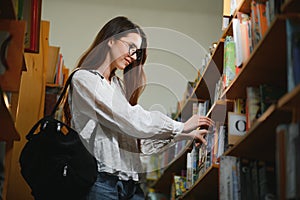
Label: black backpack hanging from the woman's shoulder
xmin=19 ymin=71 xmax=98 ymax=200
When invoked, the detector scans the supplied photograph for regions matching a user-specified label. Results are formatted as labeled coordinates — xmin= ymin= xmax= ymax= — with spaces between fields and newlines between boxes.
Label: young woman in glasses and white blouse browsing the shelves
xmin=69 ymin=17 xmax=213 ymax=200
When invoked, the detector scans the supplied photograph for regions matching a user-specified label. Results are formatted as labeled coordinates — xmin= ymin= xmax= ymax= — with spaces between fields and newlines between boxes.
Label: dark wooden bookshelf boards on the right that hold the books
xmin=148 ymin=0 xmax=300 ymax=199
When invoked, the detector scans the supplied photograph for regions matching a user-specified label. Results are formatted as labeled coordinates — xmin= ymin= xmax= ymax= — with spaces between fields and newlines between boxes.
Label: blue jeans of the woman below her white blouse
xmin=86 ymin=172 xmax=145 ymax=200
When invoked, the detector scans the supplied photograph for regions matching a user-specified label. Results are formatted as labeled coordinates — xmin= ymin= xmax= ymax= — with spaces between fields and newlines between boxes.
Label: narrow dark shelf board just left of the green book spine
xmin=194 ymin=40 xmax=224 ymax=99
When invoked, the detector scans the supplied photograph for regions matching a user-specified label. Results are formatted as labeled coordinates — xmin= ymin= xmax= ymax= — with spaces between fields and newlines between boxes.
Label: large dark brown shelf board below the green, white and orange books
xmin=222 ymin=16 xmax=287 ymax=99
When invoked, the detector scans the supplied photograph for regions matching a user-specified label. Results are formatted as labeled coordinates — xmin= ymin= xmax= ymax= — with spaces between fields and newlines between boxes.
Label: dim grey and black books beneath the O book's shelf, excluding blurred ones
xmin=219 ymin=156 xmax=276 ymax=200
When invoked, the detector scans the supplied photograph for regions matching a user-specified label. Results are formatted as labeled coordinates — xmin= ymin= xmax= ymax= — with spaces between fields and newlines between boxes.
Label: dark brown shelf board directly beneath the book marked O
xmin=224 ymin=104 xmax=291 ymax=162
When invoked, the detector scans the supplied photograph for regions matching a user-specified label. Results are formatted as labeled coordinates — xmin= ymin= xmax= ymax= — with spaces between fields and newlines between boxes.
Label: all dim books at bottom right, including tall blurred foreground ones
xmin=219 ymin=122 xmax=300 ymax=200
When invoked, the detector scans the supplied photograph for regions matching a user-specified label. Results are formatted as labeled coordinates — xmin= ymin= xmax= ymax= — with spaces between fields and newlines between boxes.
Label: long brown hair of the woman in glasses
xmin=64 ymin=16 xmax=147 ymax=123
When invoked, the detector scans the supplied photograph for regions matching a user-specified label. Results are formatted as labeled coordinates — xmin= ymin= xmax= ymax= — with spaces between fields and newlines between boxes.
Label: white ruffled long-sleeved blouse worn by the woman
xmin=69 ymin=70 xmax=183 ymax=181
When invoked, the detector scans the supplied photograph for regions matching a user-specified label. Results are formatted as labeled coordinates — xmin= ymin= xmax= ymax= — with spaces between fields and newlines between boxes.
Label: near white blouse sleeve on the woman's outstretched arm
xmin=72 ymin=70 xmax=183 ymax=139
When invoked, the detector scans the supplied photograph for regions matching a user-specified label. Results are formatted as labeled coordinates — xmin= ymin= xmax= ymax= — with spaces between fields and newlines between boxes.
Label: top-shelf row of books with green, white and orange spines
xmin=223 ymin=0 xmax=281 ymax=88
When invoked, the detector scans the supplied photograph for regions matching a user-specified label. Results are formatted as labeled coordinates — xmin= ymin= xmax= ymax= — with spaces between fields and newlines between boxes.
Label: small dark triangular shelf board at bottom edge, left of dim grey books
xmin=179 ymin=164 xmax=219 ymax=199
